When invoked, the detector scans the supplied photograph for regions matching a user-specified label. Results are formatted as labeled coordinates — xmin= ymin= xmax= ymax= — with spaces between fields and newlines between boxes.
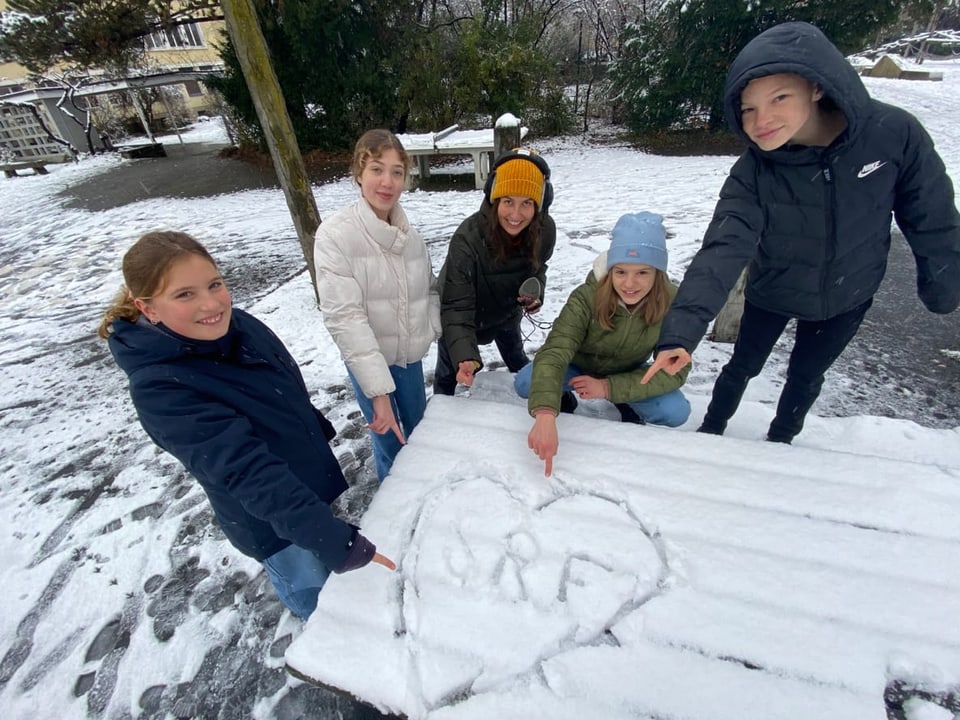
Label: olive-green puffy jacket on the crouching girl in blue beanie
xmin=527 ymin=254 xmax=690 ymax=415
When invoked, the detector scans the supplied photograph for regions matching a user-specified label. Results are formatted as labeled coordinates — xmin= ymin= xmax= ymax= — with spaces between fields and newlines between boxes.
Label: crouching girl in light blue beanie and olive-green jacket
xmin=514 ymin=212 xmax=690 ymax=476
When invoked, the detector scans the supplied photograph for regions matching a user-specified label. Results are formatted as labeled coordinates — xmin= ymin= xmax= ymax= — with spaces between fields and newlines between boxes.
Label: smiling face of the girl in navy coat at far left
xmin=134 ymin=254 xmax=231 ymax=340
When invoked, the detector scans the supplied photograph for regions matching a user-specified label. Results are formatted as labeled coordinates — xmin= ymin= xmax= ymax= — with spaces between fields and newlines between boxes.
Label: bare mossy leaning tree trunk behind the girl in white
xmin=221 ymin=0 xmax=320 ymax=293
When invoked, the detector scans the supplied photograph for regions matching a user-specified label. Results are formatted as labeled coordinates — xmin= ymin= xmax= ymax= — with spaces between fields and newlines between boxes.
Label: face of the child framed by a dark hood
xmin=740 ymin=73 xmax=823 ymax=150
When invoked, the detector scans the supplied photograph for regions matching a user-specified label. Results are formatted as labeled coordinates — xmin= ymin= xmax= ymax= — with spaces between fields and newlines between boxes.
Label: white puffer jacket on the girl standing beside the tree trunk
xmin=314 ymin=198 xmax=440 ymax=398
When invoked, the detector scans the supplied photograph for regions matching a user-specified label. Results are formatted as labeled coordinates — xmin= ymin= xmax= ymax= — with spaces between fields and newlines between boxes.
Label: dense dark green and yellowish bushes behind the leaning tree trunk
xmin=208 ymin=0 xmax=573 ymax=151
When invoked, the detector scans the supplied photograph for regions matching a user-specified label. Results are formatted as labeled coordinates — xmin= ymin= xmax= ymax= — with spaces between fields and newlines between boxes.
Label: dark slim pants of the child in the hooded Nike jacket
xmin=700 ymin=298 xmax=873 ymax=442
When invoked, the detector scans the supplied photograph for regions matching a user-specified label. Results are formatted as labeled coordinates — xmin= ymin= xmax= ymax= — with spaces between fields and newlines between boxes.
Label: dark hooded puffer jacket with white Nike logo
xmin=659 ymin=22 xmax=960 ymax=352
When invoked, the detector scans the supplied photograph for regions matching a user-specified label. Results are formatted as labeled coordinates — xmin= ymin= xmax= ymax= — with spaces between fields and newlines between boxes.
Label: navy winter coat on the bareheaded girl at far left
xmin=109 ymin=309 xmax=355 ymax=570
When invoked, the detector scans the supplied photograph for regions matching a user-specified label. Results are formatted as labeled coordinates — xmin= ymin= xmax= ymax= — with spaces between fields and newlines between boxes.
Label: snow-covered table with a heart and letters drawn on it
xmin=286 ymin=386 xmax=960 ymax=720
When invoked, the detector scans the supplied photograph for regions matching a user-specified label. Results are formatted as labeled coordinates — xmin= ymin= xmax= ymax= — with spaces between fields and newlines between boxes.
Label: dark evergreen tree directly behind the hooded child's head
xmin=613 ymin=0 xmax=901 ymax=133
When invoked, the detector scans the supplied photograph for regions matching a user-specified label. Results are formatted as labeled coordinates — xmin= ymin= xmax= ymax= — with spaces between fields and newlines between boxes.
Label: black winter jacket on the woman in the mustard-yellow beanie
xmin=438 ymin=200 xmax=557 ymax=368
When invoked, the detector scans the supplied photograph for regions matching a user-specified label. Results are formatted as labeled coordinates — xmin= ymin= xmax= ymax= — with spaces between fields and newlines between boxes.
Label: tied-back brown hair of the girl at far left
xmin=97 ymin=231 xmax=217 ymax=340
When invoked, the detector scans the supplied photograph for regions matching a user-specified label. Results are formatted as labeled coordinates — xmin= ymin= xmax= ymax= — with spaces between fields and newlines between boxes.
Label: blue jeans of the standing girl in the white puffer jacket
xmin=347 ymin=361 xmax=427 ymax=482
